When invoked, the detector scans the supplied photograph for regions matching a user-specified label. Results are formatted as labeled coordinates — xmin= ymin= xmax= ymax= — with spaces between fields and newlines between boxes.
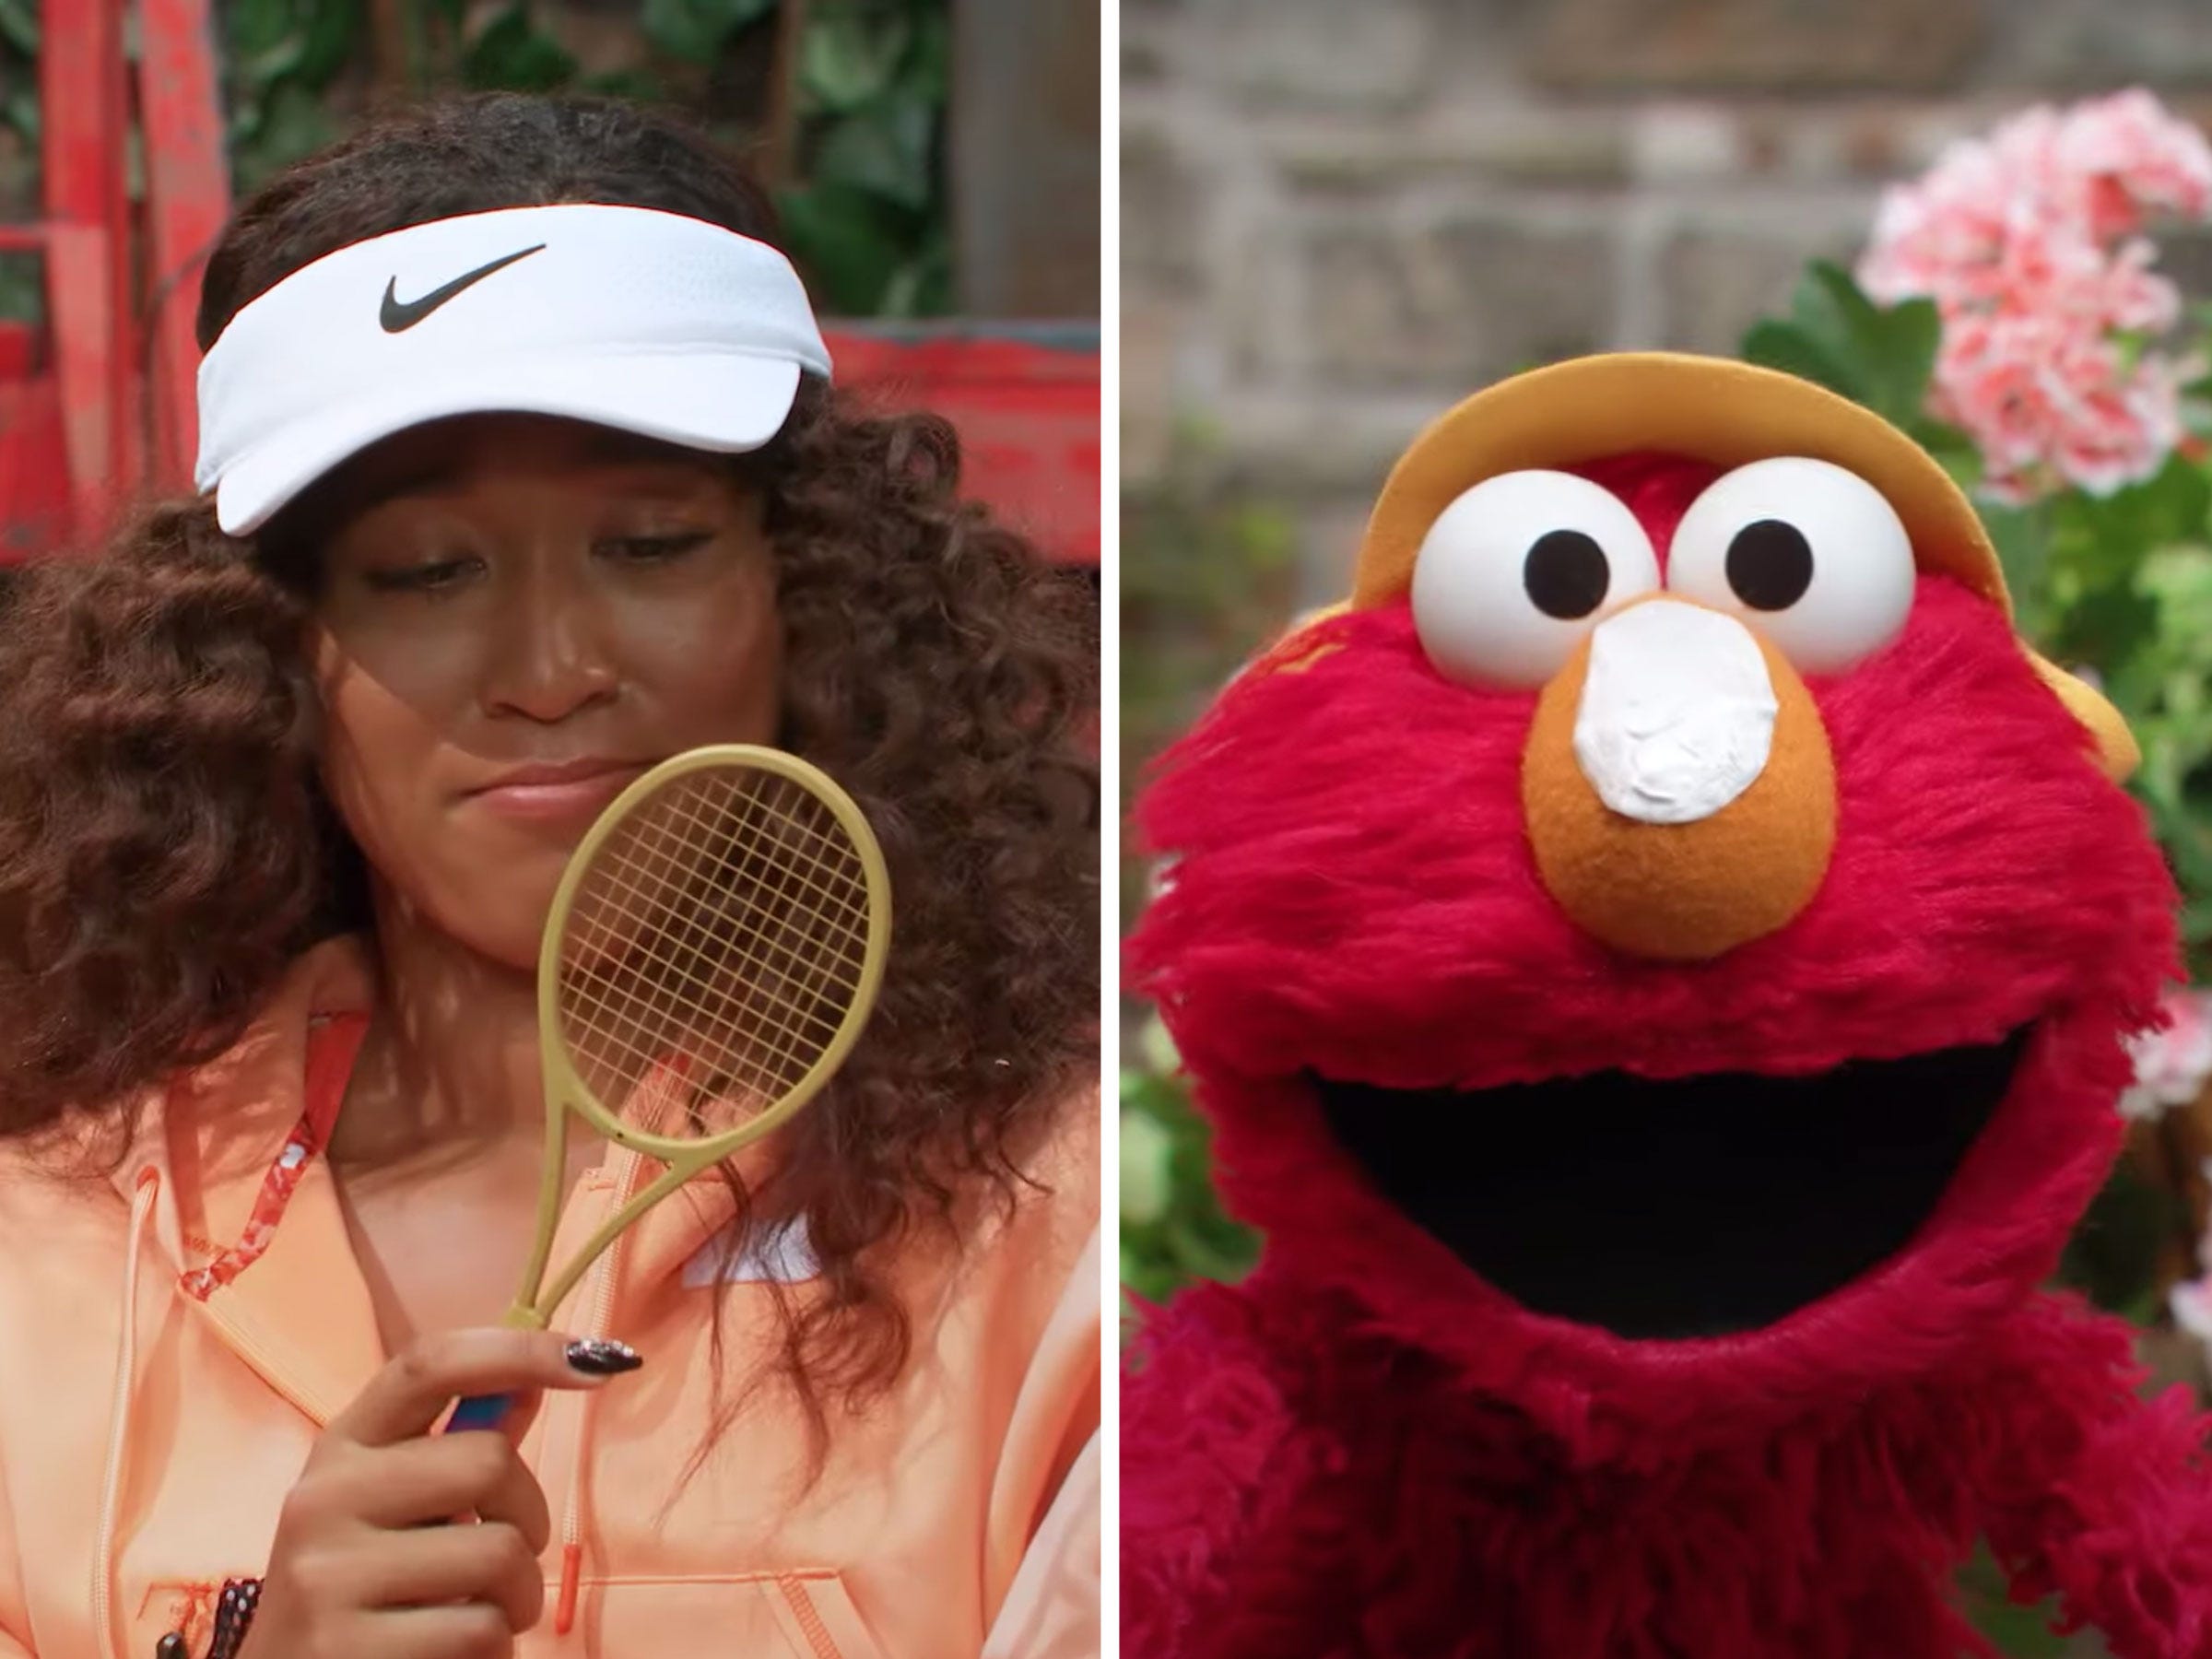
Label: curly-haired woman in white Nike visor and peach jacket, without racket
xmin=0 ymin=98 xmax=1100 ymax=1659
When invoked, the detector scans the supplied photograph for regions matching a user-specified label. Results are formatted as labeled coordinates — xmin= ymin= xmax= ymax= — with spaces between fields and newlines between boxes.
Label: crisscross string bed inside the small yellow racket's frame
xmin=559 ymin=770 xmax=869 ymax=1133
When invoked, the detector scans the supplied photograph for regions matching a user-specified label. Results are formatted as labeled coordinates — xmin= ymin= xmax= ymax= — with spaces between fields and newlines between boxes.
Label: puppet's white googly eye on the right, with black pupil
xmin=1665 ymin=455 xmax=1913 ymax=675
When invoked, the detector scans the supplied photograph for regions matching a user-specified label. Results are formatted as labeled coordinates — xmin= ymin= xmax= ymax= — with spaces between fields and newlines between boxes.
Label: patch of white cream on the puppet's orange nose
xmin=1575 ymin=599 xmax=1781 ymax=823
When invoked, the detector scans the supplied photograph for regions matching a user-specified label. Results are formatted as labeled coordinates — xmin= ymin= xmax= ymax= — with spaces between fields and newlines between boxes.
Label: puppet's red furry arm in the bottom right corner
xmin=1959 ymin=1299 xmax=2212 ymax=1659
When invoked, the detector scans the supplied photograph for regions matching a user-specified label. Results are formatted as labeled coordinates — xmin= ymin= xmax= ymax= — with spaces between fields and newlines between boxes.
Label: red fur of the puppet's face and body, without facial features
xmin=1122 ymin=458 xmax=2212 ymax=1659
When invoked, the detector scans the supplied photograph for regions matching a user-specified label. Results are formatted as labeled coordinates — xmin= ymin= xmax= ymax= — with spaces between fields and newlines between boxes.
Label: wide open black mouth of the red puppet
xmin=1314 ymin=1029 xmax=2029 ymax=1340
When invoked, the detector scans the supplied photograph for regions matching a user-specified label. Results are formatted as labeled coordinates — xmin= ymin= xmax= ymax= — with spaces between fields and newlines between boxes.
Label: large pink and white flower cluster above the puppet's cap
xmin=1858 ymin=90 xmax=2212 ymax=500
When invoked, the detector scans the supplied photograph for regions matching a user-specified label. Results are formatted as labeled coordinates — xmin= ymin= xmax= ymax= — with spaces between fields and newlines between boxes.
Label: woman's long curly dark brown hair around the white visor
xmin=0 ymin=95 xmax=1100 ymax=1429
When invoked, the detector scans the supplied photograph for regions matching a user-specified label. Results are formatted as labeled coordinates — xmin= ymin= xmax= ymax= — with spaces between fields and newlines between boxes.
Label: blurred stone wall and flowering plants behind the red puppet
xmin=1119 ymin=0 xmax=2212 ymax=1654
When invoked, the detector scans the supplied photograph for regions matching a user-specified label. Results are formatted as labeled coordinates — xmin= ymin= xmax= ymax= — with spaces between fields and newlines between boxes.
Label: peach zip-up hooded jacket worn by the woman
xmin=0 ymin=940 xmax=1101 ymax=1659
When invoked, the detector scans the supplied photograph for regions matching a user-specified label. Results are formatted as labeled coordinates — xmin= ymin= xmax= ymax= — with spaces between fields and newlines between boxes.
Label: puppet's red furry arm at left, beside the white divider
xmin=1122 ymin=1285 xmax=1334 ymax=1659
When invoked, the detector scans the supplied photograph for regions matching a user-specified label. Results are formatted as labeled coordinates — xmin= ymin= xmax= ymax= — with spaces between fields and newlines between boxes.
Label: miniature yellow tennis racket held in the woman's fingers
xmin=447 ymin=746 xmax=891 ymax=1431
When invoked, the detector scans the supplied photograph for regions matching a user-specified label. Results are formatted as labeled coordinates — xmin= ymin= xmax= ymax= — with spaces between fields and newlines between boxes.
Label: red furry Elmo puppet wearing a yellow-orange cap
xmin=1122 ymin=354 xmax=2212 ymax=1659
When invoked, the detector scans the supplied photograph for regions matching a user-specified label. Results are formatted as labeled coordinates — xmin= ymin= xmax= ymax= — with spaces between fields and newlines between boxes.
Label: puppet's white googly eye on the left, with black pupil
xmin=1414 ymin=471 xmax=1659 ymax=688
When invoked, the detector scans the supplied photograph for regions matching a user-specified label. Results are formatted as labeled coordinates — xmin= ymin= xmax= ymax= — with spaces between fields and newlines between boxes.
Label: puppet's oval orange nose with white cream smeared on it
xmin=1522 ymin=597 xmax=1836 ymax=962
